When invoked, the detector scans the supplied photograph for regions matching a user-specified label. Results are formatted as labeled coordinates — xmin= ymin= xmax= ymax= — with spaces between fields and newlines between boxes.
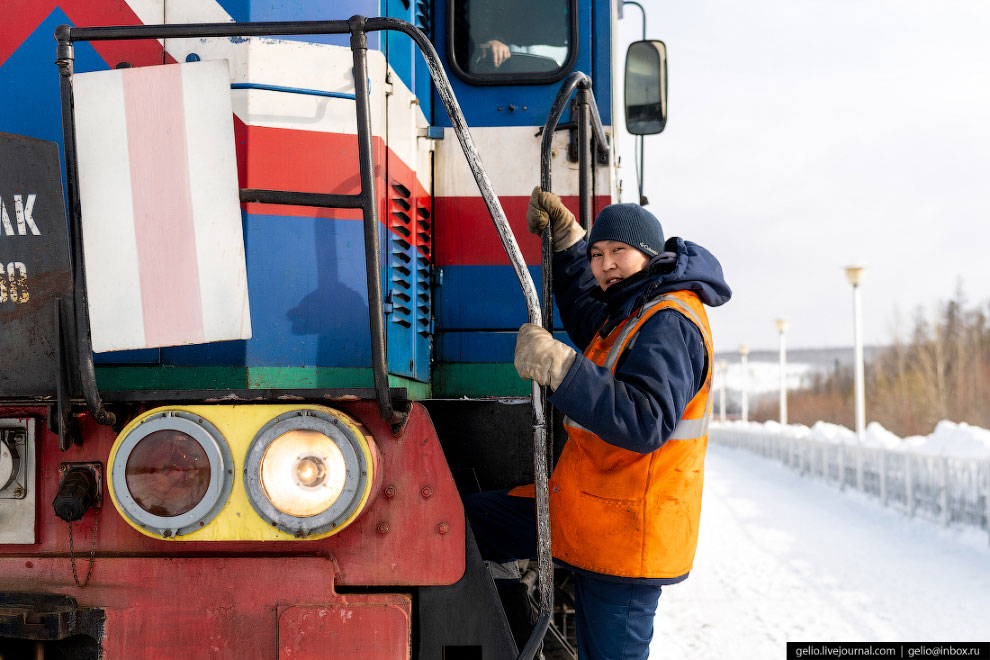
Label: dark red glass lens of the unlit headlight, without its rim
xmin=124 ymin=429 xmax=212 ymax=517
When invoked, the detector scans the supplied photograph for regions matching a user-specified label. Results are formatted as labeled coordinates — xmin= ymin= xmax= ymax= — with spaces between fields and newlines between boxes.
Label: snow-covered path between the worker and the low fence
xmin=650 ymin=444 xmax=990 ymax=660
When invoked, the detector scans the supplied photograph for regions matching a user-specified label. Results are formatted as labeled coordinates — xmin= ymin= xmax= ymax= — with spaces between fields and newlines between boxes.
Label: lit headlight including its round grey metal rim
xmin=244 ymin=409 xmax=376 ymax=538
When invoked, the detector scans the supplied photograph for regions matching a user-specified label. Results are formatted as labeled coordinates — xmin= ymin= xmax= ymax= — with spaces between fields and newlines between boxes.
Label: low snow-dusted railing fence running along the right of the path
xmin=709 ymin=424 xmax=990 ymax=534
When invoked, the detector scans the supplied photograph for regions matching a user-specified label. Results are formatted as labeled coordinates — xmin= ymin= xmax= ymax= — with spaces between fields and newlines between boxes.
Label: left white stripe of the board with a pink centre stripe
xmin=74 ymin=71 xmax=144 ymax=352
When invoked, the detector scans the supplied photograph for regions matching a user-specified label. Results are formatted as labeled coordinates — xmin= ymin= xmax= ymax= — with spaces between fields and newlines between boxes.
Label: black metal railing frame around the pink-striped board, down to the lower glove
xmin=55 ymin=16 xmax=545 ymax=438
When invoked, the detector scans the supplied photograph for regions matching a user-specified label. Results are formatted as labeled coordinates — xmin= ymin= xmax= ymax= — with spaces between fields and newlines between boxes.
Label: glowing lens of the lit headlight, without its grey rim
xmin=259 ymin=430 xmax=347 ymax=518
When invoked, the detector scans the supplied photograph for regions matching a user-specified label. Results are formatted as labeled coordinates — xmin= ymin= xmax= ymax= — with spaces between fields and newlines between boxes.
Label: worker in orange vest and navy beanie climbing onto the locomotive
xmin=465 ymin=188 xmax=732 ymax=660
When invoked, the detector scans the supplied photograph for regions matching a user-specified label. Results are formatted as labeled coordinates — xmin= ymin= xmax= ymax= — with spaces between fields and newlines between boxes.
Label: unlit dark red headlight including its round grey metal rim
xmin=110 ymin=410 xmax=234 ymax=538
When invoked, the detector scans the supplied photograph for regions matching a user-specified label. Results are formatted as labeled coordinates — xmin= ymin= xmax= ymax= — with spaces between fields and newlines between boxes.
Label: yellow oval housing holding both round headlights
xmin=109 ymin=405 xmax=381 ymax=541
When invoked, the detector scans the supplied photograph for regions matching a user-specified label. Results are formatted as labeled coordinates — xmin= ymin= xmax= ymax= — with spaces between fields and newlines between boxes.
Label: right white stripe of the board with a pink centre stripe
xmin=182 ymin=61 xmax=251 ymax=341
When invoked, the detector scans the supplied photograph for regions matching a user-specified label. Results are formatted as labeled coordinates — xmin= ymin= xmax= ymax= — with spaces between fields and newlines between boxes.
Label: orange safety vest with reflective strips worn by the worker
xmin=511 ymin=291 xmax=714 ymax=578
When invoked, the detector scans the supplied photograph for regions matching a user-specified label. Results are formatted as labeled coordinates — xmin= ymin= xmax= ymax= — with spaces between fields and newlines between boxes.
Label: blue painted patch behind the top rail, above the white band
xmin=211 ymin=0 xmax=381 ymax=50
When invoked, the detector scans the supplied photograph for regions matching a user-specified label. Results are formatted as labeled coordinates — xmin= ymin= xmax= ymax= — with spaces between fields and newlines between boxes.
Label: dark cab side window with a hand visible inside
xmin=449 ymin=0 xmax=577 ymax=84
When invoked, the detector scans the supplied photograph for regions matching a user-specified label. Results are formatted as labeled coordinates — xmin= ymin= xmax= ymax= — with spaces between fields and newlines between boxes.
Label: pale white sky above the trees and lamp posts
xmin=616 ymin=0 xmax=990 ymax=350
